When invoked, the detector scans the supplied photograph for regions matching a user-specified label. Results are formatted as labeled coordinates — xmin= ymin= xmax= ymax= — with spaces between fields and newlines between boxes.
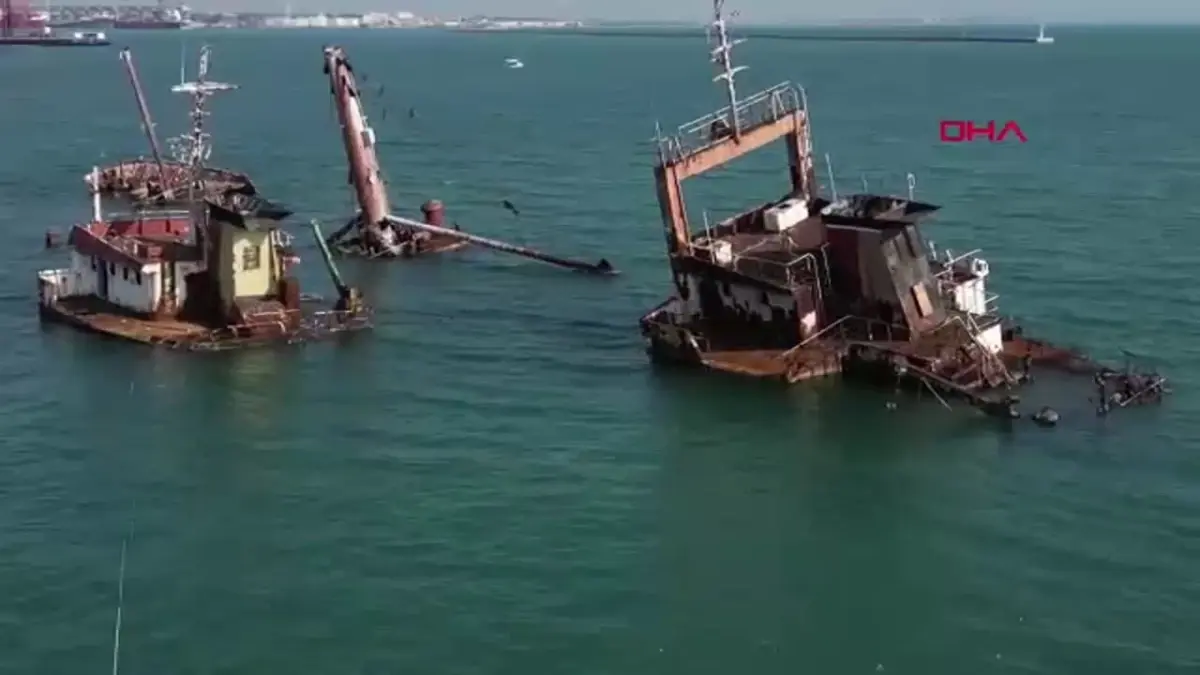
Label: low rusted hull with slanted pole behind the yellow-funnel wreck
xmin=84 ymin=46 xmax=280 ymax=219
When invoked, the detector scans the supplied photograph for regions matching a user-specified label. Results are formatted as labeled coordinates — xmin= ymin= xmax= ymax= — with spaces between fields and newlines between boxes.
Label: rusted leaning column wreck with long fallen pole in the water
xmin=323 ymin=47 xmax=616 ymax=275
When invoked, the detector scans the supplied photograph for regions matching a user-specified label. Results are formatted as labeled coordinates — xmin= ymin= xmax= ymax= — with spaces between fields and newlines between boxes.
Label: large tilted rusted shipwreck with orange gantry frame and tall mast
xmin=641 ymin=0 xmax=1166 ymax=424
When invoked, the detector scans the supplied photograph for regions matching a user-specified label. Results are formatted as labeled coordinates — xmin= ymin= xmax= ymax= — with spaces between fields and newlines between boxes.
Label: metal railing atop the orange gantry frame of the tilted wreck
xmin=654 ymin=82 xmax=808 ymax=165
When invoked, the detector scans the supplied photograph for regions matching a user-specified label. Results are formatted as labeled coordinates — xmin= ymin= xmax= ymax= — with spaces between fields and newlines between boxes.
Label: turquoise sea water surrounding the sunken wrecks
xmin=0 ymin=23 xmax=1200 ymax=675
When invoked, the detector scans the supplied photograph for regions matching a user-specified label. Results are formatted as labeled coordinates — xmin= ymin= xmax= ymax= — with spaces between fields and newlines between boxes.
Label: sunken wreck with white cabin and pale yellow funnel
xmin=37 ymin=45 xmax=371 ymax=351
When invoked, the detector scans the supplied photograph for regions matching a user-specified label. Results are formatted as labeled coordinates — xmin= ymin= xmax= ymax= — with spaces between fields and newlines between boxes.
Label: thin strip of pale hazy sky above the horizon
xmin=100 ymin=0 xmax=1200 ymax=23
